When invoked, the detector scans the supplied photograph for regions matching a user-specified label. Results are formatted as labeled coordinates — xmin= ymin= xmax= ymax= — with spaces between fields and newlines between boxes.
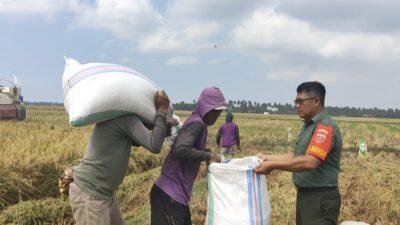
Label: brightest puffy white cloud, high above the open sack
xmin=233 ymin=9 xmax=322 ymax=55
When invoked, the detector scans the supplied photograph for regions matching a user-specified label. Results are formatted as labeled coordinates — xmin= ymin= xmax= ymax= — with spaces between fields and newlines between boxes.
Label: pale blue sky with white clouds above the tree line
xmin=0 ymin=0 xmax=400 ymax=108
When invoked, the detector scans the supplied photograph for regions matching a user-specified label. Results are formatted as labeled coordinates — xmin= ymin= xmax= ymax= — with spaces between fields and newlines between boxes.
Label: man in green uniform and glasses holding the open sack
xmin=254 ymin=81 xmax=342 ymax=225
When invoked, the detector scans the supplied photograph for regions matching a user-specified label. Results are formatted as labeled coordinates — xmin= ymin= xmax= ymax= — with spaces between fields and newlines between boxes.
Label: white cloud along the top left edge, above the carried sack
xmin=0 ymin=0 xmax=163 ymax=41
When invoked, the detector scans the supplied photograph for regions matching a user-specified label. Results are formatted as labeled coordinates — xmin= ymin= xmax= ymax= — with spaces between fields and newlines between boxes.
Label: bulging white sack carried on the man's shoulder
xmin=62 ymin=58 xmax=166 ymax=126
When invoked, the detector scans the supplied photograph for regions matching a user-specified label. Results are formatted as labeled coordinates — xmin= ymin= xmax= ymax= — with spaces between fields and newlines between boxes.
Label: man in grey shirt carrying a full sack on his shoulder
xmin=69 ymin=91 xmax=170 ymax=225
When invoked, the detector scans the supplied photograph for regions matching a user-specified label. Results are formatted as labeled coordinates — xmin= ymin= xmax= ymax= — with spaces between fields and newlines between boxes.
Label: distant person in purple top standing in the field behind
xmin=216 ymin=112 xmax=240 ymax=161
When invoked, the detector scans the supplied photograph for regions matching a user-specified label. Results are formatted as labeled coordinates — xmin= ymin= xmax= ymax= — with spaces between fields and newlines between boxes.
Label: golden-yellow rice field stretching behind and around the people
xmin=0 ymin=106 xmax=400 ymax=225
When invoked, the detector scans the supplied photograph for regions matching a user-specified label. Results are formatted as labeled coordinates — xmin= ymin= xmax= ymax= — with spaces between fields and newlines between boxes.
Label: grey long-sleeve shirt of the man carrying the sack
xmin=74 ymin=113 xmax=166 ymax=199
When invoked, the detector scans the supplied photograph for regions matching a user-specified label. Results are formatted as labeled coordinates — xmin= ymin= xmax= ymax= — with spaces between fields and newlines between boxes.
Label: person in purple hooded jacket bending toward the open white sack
xmin=150 ymin=87 xmax=226 ymax=225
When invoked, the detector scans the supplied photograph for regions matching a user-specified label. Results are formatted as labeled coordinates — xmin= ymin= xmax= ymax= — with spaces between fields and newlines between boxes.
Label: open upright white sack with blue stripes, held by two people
xmin=205 ymin=157 xmax=271 ymax=225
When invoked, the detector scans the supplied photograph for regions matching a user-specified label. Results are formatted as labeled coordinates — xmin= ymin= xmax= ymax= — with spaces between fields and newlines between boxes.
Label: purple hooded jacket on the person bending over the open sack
xmin=155 ymin=87 xmax=226 ymax=205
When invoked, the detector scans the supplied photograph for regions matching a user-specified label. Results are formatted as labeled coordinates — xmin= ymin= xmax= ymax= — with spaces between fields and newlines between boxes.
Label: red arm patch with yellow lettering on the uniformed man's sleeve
xmin=306 ymin=124 xmax=333 ymax=160
